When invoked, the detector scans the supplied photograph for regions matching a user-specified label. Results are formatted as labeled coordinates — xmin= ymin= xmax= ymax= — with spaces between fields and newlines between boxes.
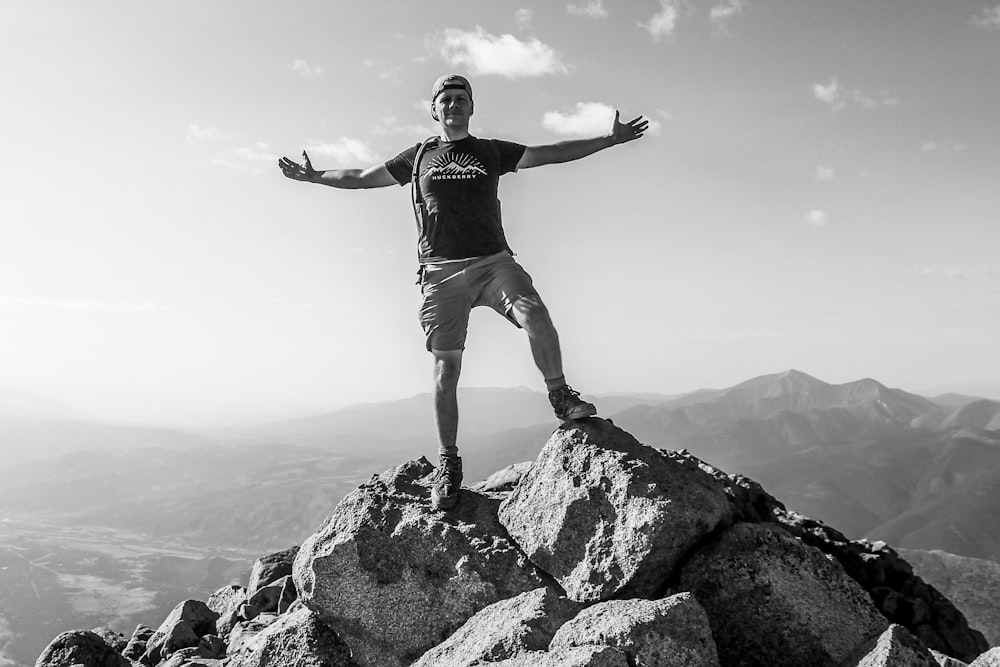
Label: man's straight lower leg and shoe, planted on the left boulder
xmin=431 ymin=350 xmax=462 ymax=510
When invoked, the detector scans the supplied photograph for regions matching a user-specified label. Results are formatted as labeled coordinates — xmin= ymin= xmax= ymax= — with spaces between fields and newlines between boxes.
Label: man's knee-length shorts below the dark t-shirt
xmin=420 ymin=251 xmax=538 ymax=352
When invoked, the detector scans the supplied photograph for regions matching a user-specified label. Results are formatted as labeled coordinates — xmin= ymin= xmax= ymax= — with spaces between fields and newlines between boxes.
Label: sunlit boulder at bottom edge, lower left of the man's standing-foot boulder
xmin=227 ymin=608 xmax=357 ymax=667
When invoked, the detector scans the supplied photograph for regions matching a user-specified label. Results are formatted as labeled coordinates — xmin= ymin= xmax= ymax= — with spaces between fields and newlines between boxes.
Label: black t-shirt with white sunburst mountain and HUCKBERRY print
xmin=385 ymin=136 xmax=525 ymax=263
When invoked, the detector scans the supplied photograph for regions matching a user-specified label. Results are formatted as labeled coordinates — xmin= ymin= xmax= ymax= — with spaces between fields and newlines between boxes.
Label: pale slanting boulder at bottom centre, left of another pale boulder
xmin=413 ymin=588 xmax=581 ymax=667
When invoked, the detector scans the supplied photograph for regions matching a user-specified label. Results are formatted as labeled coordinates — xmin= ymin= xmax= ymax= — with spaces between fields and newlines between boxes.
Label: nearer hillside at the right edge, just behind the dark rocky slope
xmin=899 ymin=549 xmax=1000 ymax=646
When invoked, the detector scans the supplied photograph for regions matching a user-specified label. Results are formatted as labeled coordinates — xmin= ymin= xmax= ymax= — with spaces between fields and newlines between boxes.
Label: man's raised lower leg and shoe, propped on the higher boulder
xmin=513 ymin=294 xmax=597 ymax=420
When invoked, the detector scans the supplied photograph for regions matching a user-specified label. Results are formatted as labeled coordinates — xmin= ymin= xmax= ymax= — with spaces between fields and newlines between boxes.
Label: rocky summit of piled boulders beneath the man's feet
xmin=36 ymin=418 xmax=998 ymax=667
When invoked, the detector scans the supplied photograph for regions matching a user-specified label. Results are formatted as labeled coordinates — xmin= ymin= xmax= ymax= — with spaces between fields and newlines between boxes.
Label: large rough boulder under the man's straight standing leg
xmin=293 ymin=458 xmax=545 ymax=667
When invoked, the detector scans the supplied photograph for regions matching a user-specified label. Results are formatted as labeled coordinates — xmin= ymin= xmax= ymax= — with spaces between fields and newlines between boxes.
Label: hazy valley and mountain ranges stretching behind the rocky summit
xmin=0 ymin=371 xmax=1000 ymax=667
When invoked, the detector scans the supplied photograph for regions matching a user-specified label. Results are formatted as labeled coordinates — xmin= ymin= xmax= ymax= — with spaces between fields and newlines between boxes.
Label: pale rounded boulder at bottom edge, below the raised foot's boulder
xmin=550 ymin=593 xmax=719 ymax=667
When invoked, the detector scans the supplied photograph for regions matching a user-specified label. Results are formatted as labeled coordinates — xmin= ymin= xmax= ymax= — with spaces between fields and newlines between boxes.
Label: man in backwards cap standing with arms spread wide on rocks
xmin=278 ymin=74 xmax=648 ymax=510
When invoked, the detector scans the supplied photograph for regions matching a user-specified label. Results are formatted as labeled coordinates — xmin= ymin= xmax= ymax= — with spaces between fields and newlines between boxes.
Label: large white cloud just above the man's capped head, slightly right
xmin=433 ymin=26 xmax=568 ymax=79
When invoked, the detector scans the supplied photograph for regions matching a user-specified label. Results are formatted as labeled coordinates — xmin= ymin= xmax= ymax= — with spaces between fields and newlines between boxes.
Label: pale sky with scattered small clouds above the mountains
xmin=0 ymin=0 xmax=1000 ymax=424
